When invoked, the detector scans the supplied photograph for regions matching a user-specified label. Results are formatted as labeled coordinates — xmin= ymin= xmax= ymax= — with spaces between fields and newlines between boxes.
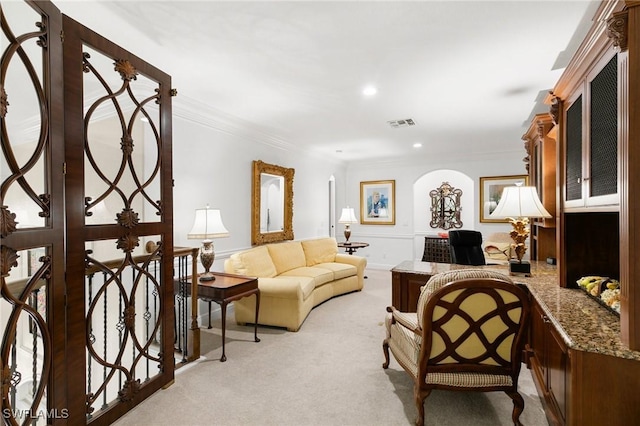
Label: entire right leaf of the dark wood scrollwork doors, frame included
xmin=63 ymin=17 xmax=174 ymax=424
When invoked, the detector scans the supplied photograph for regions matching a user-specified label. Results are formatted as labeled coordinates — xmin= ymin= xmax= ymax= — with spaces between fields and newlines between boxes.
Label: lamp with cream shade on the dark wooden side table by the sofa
xmin=187 ymin=204 xmax=229 ymax=281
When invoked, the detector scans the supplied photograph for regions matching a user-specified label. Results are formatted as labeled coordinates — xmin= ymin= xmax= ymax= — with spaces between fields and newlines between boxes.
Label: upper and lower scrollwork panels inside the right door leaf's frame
xmin=83 ymin=46 xmax=166 ymax=420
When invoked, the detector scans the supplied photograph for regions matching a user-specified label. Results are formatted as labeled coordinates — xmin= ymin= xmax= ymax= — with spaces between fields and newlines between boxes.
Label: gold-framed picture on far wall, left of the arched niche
xmin=360 ymin=180 xmax=396 ymax=225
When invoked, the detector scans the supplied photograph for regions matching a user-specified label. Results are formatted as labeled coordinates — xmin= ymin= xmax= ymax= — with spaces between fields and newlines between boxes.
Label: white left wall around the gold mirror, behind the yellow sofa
xmin=173 ymin=106 xmax=345 ymax=271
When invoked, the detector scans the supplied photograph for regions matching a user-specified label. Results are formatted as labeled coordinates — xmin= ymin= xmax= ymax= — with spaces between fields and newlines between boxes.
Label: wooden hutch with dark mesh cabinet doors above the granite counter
xmin=553 ymin=0 xmax=640 ymax=351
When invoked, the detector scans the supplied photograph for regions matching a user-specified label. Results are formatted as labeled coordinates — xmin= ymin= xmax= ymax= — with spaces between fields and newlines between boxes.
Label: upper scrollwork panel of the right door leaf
xmin=83 ymin=46 xmax=162 ymax=229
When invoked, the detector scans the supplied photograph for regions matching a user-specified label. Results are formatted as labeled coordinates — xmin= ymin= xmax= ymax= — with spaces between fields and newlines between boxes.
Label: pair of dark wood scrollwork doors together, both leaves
xmin=0 ymin=1 xmax=174 ymax=425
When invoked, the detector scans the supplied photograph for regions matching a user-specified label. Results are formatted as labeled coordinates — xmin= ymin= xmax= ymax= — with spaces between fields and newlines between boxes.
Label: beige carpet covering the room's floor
xmin=116 ymin=270 xmax=548 ymax=426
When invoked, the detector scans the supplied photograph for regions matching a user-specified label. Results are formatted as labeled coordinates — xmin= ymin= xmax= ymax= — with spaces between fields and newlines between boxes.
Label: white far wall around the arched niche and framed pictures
xmin=346 ymin=151 xmax=526 ymax=269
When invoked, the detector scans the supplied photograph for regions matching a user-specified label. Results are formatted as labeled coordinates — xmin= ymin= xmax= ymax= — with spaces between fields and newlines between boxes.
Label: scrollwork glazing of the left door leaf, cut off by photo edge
xmin=0 ymin=2 xmax=53 ymax=425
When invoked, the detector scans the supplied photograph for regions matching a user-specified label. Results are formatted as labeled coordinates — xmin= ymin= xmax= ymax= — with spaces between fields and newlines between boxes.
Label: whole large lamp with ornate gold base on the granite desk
xmin=489 ymin=185 xmax=551 ymax=276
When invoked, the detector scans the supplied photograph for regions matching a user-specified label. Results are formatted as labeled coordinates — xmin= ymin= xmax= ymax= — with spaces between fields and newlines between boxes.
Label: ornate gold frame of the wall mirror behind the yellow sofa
xmin=251 ymin=160 xmax=295 ymax=245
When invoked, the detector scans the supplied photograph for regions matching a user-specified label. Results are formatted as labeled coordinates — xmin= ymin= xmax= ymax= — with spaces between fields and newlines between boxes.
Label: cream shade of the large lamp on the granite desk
xmin=489 ymin=186 xmax=551 ymax=219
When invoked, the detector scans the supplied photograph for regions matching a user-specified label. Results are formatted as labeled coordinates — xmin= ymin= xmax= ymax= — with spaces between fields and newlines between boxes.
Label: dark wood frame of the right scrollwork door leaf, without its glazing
xmin=63 ymin=16 xmax=174 ymax=424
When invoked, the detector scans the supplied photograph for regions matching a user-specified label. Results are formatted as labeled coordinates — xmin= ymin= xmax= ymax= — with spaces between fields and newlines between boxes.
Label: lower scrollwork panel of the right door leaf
xmin=85 ymin=240 xmax=163 ymax=417
